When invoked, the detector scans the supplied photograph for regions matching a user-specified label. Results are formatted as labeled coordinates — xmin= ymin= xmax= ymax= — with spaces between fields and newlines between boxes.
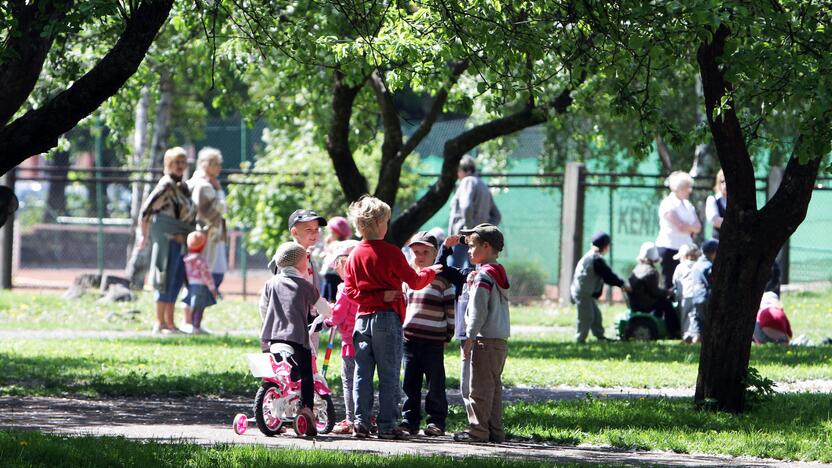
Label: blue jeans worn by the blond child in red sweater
xmin=352 ymin=310 xmax=402 ymax=433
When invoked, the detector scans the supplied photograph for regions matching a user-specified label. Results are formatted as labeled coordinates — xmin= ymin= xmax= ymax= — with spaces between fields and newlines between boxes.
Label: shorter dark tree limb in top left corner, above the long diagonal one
xmin=0 ymin=0 xmax=73 ymax=125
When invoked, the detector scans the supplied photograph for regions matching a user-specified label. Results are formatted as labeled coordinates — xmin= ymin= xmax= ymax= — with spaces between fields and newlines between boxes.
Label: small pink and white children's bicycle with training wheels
xmin=234 ymin=343 xmax=335 ymax=437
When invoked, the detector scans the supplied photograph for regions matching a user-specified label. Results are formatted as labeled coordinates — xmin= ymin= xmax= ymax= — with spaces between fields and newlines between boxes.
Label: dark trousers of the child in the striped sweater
xmin=402 ymin=340 xmax=448 ymax=430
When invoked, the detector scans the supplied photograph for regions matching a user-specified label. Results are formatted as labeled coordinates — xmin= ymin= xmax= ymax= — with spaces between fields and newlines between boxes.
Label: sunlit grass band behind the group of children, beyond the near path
xmin=0 ymin=336 xmax=832 ymax=396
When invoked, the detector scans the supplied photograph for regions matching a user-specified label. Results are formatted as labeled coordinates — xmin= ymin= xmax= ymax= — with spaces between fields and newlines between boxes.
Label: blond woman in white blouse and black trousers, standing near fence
xmin=656 ymin=171 xmax=702 ymax=289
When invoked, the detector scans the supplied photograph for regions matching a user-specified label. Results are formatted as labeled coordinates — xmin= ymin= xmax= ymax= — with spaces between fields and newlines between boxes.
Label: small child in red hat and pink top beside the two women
xmin=183 ymin=231 xmax=218 ymax=335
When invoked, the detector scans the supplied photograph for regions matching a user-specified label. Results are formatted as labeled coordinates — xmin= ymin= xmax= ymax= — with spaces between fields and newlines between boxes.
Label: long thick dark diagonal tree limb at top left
xmin=0 ymin=0 xmax=173 ymax=173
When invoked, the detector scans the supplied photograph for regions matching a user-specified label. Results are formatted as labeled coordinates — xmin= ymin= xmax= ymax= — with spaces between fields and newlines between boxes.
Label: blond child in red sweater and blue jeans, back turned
xmin=344 ymin=195 xmax=442 ymax=439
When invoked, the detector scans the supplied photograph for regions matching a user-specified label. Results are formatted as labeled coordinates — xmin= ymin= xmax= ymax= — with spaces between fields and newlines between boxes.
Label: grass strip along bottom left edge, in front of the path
xmin=0 ymin=430 xmax=564 ymax=468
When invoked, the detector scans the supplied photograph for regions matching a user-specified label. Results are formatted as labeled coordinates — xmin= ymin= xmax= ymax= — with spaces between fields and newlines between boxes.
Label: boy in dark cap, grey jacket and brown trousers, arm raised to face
xmin=454 ymin=223 xmax=511 ymax=443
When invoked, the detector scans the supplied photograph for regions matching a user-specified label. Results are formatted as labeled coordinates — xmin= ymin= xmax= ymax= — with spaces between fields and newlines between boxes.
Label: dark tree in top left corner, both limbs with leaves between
xmin=0 ymin=0 xmax=173 ymax=173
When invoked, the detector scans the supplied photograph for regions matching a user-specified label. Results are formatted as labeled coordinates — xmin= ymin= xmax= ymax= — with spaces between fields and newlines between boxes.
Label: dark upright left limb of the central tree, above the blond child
xmin=326 ymin=70 xmax=369 ymax=202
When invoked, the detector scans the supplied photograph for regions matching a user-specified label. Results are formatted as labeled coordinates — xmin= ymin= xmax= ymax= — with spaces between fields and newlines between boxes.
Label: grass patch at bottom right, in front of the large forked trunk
xmin=451 ymin=394 xmax=832 ymax=462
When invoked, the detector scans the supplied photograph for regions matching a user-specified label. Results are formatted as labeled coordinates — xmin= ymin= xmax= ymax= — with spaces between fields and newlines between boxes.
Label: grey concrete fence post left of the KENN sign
xmin=558 ymin=162 xmax=585 ymax=303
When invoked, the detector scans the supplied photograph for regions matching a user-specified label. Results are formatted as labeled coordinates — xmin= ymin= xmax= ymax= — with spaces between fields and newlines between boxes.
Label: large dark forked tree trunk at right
xmin=695 ymin=25 xmax=829 ymax=412
